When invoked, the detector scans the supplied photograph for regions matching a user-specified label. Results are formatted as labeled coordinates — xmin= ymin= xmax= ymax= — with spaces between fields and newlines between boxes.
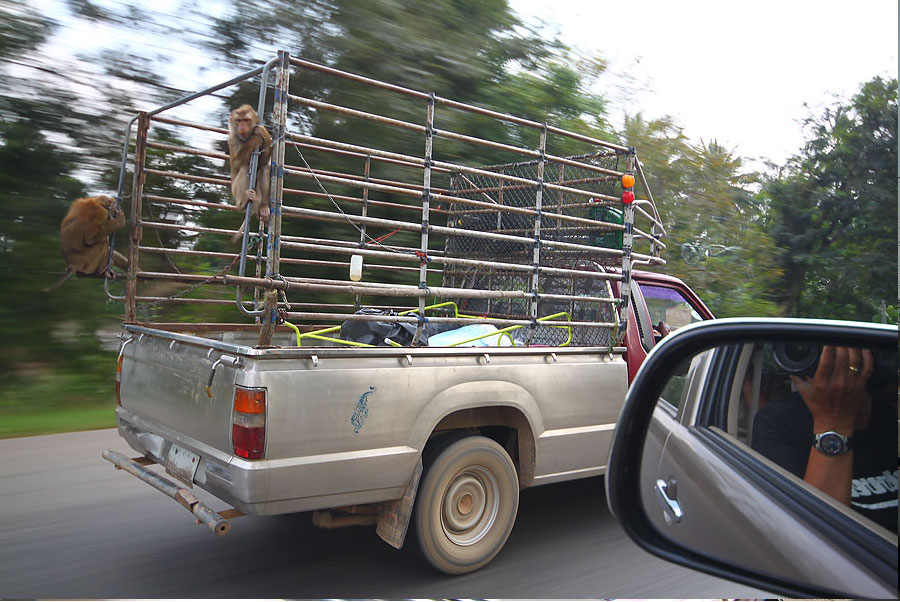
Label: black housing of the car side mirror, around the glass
xmin=606 ymin=318 xmax=898 ymax=598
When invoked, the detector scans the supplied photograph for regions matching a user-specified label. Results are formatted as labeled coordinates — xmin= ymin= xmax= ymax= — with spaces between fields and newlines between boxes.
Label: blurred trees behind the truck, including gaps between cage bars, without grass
xmin=0 ymin=0 xmax=897 ymax=420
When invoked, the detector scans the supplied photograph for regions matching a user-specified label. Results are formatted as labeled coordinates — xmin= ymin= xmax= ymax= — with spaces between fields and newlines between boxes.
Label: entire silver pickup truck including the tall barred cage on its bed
xmin=103 ymin=52 xmax=712 ymax=573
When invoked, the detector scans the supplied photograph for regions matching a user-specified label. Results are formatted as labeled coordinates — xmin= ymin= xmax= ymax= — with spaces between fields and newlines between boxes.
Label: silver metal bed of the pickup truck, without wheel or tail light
xmin=117 ymin=325 xmax=627 ymax=514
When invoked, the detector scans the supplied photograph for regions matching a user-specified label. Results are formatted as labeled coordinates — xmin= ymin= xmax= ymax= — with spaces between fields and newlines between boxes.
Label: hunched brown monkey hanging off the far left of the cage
xmin=44 ymin=195 xmax=128 ymax=292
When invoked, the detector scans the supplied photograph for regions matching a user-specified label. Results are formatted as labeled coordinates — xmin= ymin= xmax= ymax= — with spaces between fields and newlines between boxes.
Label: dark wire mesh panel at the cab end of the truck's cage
xmin=443 ymin=151 xmax=623 ymax=346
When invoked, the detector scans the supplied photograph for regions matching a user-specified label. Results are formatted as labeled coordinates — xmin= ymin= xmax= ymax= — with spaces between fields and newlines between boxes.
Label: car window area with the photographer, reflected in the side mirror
xmin=696 ymin=343 xmax=898 ymax=533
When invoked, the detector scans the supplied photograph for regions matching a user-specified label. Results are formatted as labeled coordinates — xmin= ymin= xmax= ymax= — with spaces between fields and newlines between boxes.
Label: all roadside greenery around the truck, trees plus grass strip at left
xmin=0 ymin=0 xmax=897 ymax=437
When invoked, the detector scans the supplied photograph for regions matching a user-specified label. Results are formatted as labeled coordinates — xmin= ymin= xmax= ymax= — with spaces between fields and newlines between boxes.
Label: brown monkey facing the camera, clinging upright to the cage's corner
xmin=228 ymin=105 xmax=272 ymax=242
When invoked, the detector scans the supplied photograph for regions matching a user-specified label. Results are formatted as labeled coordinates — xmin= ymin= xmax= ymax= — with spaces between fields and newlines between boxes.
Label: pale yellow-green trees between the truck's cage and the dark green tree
xmin=623 ymin=114 xmax=781 ymax=317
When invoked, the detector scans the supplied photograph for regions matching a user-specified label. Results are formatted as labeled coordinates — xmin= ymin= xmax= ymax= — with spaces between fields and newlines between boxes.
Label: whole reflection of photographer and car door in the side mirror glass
xmin=641 ymin=341 xmax=900 ymax=591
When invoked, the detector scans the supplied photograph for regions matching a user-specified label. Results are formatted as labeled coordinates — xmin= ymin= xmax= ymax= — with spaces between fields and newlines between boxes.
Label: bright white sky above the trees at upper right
xmin=510 ymin=0 xmax=898 ymax=164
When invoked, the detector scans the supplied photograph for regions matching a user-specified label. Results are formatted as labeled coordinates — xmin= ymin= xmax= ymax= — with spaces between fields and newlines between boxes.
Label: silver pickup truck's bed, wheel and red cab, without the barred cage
xmin=106 ymin=272 xmax=712 ymax=573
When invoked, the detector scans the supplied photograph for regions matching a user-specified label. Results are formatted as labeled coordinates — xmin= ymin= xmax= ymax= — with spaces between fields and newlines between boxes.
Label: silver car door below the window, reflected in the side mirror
xmin=642 ymin=416 xmax=897 ymax=598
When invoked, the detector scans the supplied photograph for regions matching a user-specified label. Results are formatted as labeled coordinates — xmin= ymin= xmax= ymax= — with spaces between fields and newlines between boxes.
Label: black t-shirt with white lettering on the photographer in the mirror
xmin=752 ymin=393 xmax=897 ymax=533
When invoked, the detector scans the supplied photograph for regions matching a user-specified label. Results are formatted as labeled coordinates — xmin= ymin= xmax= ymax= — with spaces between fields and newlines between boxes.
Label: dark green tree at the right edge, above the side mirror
xmin=761 ymin=77 xmax=897 ymax=321
